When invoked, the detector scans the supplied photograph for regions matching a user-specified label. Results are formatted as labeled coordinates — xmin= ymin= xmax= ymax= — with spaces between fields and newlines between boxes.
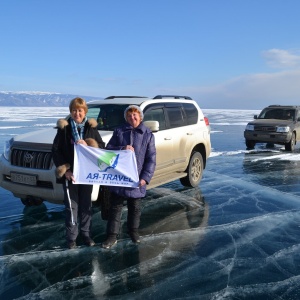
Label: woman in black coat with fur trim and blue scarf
xmin=52 ymin=97 xmax=105 ymax=249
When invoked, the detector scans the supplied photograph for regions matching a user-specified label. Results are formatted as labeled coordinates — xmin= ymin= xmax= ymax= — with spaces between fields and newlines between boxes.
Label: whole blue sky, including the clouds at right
xmin=0 ymin=0 xmax=300 ymax=109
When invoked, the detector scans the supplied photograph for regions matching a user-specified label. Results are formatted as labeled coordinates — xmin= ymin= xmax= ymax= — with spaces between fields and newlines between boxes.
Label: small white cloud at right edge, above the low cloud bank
xmin=262 ymin=49 xmax=300 ymax=69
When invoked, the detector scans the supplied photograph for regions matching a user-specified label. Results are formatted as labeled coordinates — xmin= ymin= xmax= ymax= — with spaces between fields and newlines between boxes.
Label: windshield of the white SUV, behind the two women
xmin=87 ymin=104 xmax=128 ymax=131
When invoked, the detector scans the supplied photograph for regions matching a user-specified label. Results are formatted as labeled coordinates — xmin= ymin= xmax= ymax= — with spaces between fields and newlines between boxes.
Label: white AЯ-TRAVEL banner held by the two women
xmin=73 ymin=144 xmax=139 ymax=187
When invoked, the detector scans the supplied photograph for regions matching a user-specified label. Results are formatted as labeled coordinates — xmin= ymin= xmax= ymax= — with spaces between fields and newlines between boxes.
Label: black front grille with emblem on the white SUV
xmin=10 ymin=149 xmax=52 ymax=170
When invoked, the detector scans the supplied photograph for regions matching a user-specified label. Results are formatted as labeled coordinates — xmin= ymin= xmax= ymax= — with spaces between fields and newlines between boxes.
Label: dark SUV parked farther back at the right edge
xmin=244 ymin=105 xmax=300 ymax=151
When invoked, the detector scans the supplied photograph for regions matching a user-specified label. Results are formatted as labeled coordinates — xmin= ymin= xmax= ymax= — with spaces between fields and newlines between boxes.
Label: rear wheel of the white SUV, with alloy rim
xmin=180 ymin=152 xmax=203 ymax=187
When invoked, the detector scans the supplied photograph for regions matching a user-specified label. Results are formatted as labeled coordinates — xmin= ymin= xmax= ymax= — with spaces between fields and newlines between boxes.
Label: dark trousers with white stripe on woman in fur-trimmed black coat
xmin=63 ymin=181 xmax=93 ymax=241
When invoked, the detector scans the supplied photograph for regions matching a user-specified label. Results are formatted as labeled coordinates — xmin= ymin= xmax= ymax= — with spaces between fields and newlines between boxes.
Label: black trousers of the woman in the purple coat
xmin=106 ymin=193 xmax=141 ymax=236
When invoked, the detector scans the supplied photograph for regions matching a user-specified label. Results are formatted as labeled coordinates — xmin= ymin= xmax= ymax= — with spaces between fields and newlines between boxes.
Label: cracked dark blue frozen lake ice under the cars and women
xmin=0 ymin=107 xmax=300 ymax=300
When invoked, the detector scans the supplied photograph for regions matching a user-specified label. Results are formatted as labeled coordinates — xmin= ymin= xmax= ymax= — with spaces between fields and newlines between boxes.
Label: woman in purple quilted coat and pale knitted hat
xmin=102 ymin=105 xmax=156 ymax=249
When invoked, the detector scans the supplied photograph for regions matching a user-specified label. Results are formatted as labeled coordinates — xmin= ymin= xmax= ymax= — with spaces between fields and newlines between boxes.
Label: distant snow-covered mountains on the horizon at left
xmin=0 ymin=91 xmax=103 ymax=106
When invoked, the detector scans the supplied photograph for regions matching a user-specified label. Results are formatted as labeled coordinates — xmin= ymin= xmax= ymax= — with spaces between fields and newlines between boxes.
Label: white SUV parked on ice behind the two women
xmin=0 ymin=95 xmax=211 ymax=205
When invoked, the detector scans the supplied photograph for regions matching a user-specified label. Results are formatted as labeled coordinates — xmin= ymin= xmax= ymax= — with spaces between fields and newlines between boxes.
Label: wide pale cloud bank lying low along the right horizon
xmin=185 ymin=70 xmax=300 ymax=109
